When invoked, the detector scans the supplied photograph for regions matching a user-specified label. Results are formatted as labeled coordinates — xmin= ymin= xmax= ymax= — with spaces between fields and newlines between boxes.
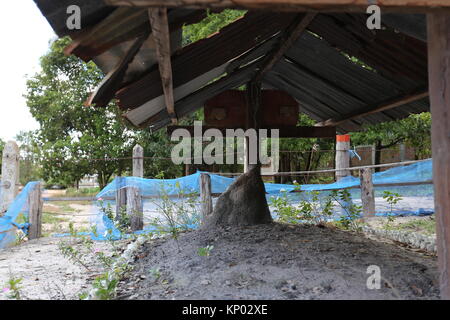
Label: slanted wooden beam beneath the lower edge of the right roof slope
xmin=316 ymin=91 xmax=428 ymax=127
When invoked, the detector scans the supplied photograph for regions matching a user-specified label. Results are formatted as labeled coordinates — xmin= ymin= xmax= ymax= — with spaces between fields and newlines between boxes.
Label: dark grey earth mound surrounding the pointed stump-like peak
xmin=120 ymin=223 xmax=439 ymax=300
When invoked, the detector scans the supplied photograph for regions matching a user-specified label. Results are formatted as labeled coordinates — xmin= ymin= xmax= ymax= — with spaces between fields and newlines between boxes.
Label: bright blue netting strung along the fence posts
xmin=0 ymin=159 xmax=434 ymax=248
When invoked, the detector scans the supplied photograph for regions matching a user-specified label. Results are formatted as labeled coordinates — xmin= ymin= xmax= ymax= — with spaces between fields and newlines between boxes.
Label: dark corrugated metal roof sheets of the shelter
xmin=35 ymin=0 xmax=429 ymax=132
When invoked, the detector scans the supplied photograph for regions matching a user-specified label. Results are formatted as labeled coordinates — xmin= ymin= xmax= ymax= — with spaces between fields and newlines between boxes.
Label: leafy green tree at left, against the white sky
xmin=25 ymin=38 xmax=135 ymax=187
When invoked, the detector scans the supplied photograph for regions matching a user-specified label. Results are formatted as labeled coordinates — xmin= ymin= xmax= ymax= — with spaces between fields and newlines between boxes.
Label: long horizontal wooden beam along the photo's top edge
xmin=105 ymin=0 xmax=450 ymax=12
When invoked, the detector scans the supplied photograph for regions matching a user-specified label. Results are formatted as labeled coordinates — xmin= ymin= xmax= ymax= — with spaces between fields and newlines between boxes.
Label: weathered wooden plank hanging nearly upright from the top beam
xmin=148 ymin=8 xmax=178 ymax=124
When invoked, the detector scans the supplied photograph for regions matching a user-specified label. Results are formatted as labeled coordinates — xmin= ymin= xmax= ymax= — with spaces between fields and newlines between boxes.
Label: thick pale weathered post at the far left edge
xmin=0 ymin=141 xmax=19 ymax=216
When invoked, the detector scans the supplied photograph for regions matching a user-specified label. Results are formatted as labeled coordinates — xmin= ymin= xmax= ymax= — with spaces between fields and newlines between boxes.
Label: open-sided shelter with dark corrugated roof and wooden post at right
xmin=35 ymin=0 xmax=450 ymax=298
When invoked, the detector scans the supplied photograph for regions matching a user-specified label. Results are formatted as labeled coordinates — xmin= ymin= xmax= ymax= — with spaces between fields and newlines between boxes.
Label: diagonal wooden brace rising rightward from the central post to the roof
xmin=255 ymin=13 xmax=317 ymax=81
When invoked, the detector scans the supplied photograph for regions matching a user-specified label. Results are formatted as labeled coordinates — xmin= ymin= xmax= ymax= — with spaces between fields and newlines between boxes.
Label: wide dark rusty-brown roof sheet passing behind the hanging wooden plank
xmin=116 ymin=12 xmax=295 ymax=110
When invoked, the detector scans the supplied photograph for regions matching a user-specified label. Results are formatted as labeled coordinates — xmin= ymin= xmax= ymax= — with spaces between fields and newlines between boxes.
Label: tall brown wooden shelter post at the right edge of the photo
xmin=427 ymin=13 xmax=450 ymax=299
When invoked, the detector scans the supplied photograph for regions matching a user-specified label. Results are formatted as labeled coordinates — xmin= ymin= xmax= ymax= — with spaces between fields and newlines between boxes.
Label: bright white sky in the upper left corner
xmin=0 ymin=0 xmax=56 ymax=141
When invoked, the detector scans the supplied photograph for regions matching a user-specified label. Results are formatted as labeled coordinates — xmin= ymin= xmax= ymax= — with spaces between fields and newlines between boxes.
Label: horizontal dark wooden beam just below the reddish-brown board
xmin=167 ymin=126 xmax=336 ymax=138
